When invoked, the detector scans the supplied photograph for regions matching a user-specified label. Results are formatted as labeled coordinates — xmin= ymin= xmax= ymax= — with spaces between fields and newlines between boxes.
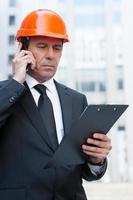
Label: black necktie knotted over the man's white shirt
xmin=34 ymin=84 xmax=58 ymax=150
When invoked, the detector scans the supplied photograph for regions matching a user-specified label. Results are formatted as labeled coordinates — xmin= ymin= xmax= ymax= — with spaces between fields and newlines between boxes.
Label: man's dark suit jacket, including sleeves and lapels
xmin=0 ymin=79 xmax=106 ymax=200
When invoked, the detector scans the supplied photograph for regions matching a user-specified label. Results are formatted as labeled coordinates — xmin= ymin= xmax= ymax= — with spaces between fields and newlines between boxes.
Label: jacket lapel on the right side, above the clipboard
xmin=55 ymin=81 xmax=72 ymax=134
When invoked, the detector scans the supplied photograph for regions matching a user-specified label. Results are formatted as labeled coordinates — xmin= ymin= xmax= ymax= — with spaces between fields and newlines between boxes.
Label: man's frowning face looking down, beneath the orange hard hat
xmin=28 ymin=36 xmax=63 ymax=83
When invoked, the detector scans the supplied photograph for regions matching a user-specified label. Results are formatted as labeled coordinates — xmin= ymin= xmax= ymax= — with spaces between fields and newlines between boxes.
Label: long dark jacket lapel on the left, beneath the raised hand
xmin=21 ymin=86 xmax=53 ymax=150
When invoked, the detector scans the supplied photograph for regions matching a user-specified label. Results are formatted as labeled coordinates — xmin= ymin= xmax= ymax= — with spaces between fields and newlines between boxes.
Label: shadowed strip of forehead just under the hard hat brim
xmin=30 ymin=36 xmax=62 ymax=44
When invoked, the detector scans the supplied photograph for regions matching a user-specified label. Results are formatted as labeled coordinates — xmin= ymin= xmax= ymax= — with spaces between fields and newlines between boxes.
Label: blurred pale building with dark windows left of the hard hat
xmin=0 ymin=0 xmax=19 ymax=79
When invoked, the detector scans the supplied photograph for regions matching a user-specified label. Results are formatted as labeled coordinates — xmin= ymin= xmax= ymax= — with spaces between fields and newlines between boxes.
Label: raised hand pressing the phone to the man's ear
xmin=12 ymin=43 xmax=36 ymax=83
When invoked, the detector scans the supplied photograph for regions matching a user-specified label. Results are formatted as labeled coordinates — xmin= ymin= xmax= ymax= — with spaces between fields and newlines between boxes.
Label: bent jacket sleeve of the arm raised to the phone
xmin=0 ymin=79 xmax=26 ymax=127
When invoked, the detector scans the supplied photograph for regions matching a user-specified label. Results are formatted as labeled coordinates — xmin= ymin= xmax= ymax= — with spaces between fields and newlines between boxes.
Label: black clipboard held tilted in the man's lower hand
xmin=49 ymin=105 xmax=128 ymax=167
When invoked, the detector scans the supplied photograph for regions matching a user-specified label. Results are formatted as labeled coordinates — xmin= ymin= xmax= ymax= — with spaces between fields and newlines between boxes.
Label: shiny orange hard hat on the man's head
xmin=16 ymin=9 xmax=69 ymax=42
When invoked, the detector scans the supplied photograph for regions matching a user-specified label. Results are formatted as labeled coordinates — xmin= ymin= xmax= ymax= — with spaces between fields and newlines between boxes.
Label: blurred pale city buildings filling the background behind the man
xmin=0 ymin=0 xmax=133 ymax=181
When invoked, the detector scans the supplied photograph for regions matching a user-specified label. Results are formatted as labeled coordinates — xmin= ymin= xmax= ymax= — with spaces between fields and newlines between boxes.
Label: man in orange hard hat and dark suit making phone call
xmin=0 ymin=9 xmax=111 ymax=200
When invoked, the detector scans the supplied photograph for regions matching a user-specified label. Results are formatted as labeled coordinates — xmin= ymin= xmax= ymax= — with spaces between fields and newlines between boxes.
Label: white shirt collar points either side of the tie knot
xmin=26 ymin=74 xmax=56 ymax=93
